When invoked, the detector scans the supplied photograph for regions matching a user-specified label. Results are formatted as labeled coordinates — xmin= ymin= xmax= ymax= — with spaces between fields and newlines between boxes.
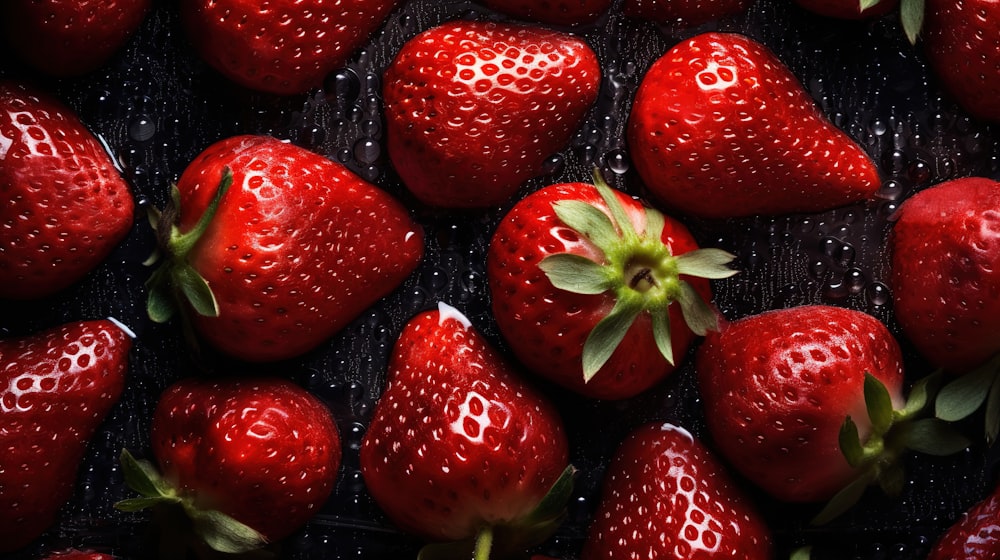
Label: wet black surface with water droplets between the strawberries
xmin=0 ymin=0 xmax=1000 ymax=560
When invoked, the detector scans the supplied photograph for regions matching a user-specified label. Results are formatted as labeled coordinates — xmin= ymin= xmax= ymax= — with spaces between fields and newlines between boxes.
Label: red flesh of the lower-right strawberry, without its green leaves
xmin=695 ymin=305 xmax=903 ymax=502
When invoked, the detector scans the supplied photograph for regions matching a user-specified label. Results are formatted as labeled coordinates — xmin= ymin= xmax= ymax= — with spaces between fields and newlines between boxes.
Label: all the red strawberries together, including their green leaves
xmin=0 ymin=0 xmax=1000 ymax=560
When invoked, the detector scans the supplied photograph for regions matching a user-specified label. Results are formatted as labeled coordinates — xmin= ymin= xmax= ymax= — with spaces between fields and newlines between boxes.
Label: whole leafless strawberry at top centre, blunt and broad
xmin=384 ymin=21 xmax=601 ymax=207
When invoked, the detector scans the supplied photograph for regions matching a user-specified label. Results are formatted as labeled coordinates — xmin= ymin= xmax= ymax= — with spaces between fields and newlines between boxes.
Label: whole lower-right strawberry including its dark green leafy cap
xmin=695 ymin=305 xmax=968 ymax=520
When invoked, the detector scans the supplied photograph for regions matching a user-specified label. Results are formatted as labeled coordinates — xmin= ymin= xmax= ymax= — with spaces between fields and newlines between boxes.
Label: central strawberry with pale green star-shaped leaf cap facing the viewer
xmin=487 ymin=176 xmax=735 ymax=399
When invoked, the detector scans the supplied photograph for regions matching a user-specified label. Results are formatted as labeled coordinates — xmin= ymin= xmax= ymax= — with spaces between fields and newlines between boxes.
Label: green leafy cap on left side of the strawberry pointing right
xmin=145 ymin=167 xmax=233 ymax=323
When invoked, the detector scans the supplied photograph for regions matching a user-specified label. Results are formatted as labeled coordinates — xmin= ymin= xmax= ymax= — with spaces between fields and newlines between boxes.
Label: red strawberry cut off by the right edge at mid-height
xmin=889 ymin=177 xmax=1000 ymax=373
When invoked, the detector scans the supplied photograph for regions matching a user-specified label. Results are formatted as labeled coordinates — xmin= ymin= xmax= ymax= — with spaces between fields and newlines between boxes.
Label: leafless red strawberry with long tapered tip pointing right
xmin=627 ymin=33 xmax=881 ymax=218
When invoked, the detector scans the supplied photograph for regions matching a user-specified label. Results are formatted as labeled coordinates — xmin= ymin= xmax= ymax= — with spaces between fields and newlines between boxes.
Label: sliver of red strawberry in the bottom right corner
xmin=927 ymin=488 xmax=1000 ymax=560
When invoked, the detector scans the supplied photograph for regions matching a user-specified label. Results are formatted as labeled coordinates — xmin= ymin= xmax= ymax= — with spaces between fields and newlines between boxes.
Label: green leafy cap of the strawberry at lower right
xmin=813 ymin=373 xmax=971 ymax=525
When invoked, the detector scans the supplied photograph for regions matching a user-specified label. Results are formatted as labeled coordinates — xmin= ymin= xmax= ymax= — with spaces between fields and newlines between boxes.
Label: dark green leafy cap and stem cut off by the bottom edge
xmin=417 ymin=465 xmax=576 ymax=560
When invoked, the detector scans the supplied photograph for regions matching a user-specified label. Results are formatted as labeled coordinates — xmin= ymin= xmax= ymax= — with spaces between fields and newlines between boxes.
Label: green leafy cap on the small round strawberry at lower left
xmin=115 ymin=449 xmax=267 ymax=554
